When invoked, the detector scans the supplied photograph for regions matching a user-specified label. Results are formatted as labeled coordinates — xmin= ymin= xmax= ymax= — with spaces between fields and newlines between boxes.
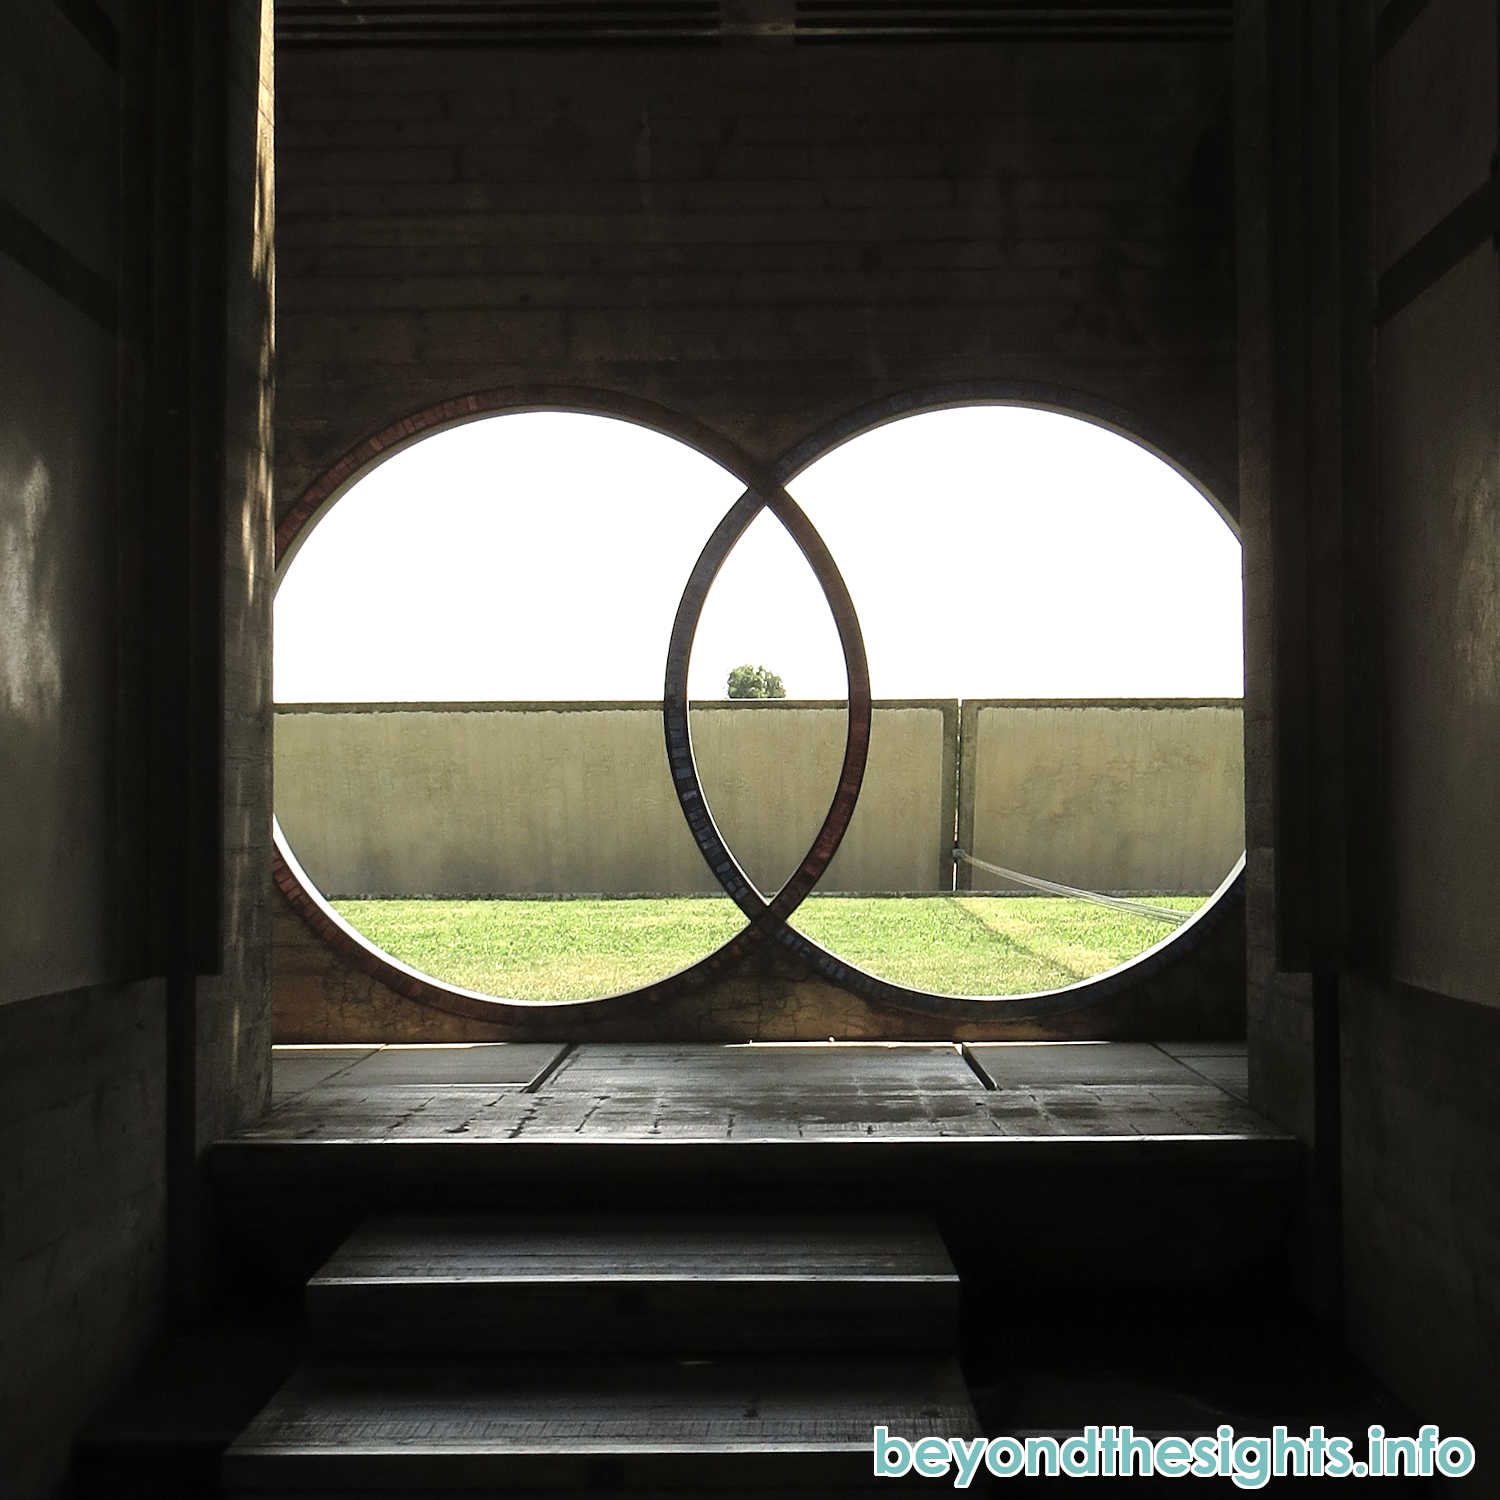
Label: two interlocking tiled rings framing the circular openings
xmin=272 ymin=381 xmax=1245 ymax=1025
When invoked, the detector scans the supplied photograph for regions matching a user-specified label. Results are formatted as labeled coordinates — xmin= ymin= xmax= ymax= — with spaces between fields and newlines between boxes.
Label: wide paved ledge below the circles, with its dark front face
xmin=209 ymin=1043 xmax=1301 ymax=1293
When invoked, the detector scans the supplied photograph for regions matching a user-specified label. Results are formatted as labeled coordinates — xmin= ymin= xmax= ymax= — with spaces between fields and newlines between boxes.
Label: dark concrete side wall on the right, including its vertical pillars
xmin=1236 ymin=0 xmax=1500 ymax=1454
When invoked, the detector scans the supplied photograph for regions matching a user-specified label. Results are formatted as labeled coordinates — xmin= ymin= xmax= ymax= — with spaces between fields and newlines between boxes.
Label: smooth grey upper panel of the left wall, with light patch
xmin=0 ymin=3 xmax=119 ymax=1001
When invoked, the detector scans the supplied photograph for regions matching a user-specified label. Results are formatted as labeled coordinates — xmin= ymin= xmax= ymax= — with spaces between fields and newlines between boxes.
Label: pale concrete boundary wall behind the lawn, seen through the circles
xmin=276 ymin=699 xmax=1244 ymax=897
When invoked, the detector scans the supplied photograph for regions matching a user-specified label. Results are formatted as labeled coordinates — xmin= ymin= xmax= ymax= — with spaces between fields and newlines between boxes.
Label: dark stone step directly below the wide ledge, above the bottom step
xmin=306 ymin=1215 xmax=959 ymax=1353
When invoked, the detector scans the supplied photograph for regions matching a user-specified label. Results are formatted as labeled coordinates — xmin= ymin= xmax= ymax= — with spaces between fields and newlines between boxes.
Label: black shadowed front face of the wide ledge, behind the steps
xmin=210 ymin=1128 xmax=1302 ymax=1296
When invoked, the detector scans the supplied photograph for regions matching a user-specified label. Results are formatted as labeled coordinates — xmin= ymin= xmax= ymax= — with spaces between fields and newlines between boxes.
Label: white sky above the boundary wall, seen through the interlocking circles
xmin=275 ymin=407 xmax=1244 ymax=702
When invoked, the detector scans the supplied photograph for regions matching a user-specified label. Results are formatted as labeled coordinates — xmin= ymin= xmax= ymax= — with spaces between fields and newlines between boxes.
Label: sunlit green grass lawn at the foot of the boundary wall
xmin=333 ymin=896 xmax=1203 ymax=1001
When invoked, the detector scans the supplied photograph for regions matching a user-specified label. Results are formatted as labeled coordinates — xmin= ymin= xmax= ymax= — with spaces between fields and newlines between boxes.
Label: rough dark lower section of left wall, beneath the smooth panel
xmin=0 ymin=983 xmax=167 ymax=1500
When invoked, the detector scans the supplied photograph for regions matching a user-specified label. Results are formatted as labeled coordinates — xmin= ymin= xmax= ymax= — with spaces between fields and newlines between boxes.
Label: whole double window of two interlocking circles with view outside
xmin=276 ymin=402 xmax=1242 ymax=1002
